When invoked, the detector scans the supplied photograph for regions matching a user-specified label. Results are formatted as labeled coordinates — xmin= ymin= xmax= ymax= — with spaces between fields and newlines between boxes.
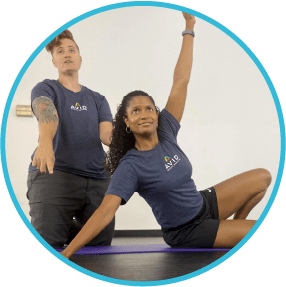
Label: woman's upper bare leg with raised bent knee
xmin=214 ymin=168 xmax=271 ymax=219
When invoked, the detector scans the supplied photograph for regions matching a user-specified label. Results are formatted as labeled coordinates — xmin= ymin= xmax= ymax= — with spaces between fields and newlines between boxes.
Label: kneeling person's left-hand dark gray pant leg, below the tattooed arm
xmin=27 ymin=170 xmax=87 ymax=248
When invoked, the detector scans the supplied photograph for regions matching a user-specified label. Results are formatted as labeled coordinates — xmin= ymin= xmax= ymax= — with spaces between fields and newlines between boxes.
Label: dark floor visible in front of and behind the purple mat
xmin=71 ymin=238 xmax=226 ymax=281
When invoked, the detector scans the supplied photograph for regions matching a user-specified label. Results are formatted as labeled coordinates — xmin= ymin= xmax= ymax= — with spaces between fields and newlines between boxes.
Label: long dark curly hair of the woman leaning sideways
xmin=104 ymin=91 xmax=160 ymax=175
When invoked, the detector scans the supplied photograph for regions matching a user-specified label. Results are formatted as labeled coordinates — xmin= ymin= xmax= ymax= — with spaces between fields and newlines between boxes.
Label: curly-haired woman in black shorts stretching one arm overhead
xmin=61 ymin=13 xmax=271 ymax=258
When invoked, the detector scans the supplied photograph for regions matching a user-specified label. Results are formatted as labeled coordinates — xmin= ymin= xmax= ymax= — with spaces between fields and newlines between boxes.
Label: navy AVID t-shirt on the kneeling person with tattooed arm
xmin=29 ymin=80 xmax=112 ymax=179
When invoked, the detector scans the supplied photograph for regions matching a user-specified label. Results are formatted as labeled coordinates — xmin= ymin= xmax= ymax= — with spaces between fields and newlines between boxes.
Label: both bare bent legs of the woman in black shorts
xmin=213 ymin=169 xmax=271 ymax=247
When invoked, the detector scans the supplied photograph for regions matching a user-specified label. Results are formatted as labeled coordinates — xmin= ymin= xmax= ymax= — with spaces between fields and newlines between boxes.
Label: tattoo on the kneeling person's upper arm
xmin=32 ymin=97 xmax=59 ymax=124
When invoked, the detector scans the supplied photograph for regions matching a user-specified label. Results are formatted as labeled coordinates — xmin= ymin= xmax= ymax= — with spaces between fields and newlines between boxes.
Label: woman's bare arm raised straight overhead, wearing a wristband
xmin=165 ymin=12 xmax=196 ymax=122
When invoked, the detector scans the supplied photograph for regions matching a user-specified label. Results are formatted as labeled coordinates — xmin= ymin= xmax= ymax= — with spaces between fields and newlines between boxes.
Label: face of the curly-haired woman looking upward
xmin=124 ymin=96 xmax=158 ymax=137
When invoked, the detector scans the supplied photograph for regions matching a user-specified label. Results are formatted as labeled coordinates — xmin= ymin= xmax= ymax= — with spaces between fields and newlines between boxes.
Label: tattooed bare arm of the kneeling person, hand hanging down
xmin=32 ymin=97 xmax=59 ymax=174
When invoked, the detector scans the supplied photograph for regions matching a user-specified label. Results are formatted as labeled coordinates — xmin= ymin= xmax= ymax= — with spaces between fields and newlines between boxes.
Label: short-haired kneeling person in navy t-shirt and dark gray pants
xmin=27 ymin=30 xmax=115 ymax=248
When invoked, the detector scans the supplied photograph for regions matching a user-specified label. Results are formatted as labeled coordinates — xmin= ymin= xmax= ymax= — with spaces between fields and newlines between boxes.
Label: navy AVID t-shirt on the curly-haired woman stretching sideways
xmin=106 ymin=109 xmax=203 ymax=228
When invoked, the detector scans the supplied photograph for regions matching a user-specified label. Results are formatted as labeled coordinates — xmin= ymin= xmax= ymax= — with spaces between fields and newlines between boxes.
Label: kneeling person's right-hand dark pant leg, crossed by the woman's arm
xmin=71 ymin=179 xmax=115 ymax=246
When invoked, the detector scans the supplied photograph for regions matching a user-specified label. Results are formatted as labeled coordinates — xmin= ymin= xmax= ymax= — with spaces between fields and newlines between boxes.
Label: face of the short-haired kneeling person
xmin=52 ymin=39 xmax=82 ymax=74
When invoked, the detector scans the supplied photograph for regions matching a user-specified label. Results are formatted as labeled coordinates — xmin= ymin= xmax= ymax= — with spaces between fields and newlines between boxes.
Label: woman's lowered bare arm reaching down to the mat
xmin=60 ymin=194 xmax=122 ymax=259
